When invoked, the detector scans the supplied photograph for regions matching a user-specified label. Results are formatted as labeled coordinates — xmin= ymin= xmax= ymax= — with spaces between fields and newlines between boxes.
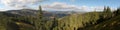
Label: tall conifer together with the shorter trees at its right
xmin=33 ymin=6 xmax=57 ymax=30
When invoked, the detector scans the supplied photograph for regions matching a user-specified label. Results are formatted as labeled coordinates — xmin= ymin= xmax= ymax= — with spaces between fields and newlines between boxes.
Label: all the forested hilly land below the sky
xmin=0 ymin=6 xmax=120 ymax=30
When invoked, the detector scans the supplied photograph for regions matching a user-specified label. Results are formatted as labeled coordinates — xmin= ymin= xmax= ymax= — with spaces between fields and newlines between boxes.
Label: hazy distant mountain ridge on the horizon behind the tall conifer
xmin=4 ymin=9 xmax=84 ymax=17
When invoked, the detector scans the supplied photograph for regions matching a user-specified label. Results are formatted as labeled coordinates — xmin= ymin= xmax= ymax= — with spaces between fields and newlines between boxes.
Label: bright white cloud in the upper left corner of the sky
xmin=0 ymin=0 xmax=43 ymax=8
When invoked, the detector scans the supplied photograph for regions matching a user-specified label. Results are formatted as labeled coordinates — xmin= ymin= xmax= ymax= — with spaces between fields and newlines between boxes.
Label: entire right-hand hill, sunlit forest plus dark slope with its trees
xmin=51 ymin=7 xmax=120 ymax=30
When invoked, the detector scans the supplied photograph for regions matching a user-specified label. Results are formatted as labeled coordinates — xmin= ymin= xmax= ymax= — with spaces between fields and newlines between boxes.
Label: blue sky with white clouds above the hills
xmin=0 ymin=0 xmax=120 ymax=11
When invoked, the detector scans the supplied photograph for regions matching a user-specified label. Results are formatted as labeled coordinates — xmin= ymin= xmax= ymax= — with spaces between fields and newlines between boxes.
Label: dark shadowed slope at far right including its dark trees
xmin=78 ymin=8 xmax=120 ymax=30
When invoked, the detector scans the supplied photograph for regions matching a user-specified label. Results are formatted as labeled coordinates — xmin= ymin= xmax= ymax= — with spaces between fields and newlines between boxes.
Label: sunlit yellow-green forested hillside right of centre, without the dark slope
xmin=54 ymin=12 xmax=99 ymax=30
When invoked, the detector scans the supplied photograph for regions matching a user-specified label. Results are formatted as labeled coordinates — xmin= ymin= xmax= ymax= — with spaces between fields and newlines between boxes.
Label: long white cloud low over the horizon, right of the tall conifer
xmin=43 ymin=2 xmax=104 ymax=11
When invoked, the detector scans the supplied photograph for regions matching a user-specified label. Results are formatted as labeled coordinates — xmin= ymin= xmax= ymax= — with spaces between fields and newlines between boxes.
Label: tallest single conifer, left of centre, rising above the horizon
xmin=34 ymin=6 xmax=43 ymax=30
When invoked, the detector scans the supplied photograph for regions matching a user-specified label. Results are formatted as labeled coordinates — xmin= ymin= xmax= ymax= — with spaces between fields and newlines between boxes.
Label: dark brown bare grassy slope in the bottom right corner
xmin=79 ymin=15 xmax=120 ymax=30
